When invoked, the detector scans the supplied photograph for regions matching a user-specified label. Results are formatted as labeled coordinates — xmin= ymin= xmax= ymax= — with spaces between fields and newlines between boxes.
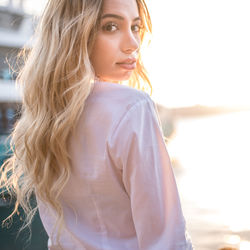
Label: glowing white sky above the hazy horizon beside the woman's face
xmin=8 ymin=0 xmax=250 ymax=106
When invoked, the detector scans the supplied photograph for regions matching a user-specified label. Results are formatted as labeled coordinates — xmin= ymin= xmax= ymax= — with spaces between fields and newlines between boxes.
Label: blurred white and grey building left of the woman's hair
xmin=0 ymin=0 xmax=34 ymax=134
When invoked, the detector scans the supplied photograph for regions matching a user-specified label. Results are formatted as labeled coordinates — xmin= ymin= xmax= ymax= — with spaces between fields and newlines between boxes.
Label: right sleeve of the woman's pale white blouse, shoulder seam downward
xmin=106 ymin=94 xmax=192 ymax=250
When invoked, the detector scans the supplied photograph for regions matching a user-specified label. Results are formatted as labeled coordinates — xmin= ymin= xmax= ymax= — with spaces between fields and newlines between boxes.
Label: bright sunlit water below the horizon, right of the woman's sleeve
xmin=168 ymin=111 xmax=250 ymax=250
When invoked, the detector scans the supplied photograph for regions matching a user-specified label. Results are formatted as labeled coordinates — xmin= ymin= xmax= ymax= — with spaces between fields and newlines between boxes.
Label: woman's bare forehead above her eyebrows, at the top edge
xmin=103 ymin=0 xmax=139 ymax=18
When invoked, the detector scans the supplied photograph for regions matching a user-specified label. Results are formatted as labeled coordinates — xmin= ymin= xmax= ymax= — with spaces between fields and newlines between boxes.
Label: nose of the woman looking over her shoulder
xmin=122 ymin=30 xmax=140 ymax=54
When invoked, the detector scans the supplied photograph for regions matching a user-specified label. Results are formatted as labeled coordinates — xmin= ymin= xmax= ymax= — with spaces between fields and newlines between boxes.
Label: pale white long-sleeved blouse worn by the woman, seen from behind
xmin=38 ymin=82 xmax=192 ymax=250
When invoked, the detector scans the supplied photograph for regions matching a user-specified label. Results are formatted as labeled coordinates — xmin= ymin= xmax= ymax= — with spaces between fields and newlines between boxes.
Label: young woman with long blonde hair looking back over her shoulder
xmin=1 ymin=0 xmax=192 ymax=250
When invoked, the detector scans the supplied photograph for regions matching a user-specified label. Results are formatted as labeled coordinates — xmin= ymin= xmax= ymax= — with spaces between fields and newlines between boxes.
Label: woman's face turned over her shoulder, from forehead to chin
xmin=90 ymin=0 xmax=141 ymax=82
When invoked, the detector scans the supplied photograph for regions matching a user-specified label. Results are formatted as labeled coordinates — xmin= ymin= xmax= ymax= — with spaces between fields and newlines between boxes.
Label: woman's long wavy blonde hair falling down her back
xmin=0 ymin=0 xmax=152 ymax=240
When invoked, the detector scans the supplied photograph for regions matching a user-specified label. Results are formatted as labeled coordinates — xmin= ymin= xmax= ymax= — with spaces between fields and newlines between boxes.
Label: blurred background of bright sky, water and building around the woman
xmin=0 ymin=0 xmax=250 ymax=250
